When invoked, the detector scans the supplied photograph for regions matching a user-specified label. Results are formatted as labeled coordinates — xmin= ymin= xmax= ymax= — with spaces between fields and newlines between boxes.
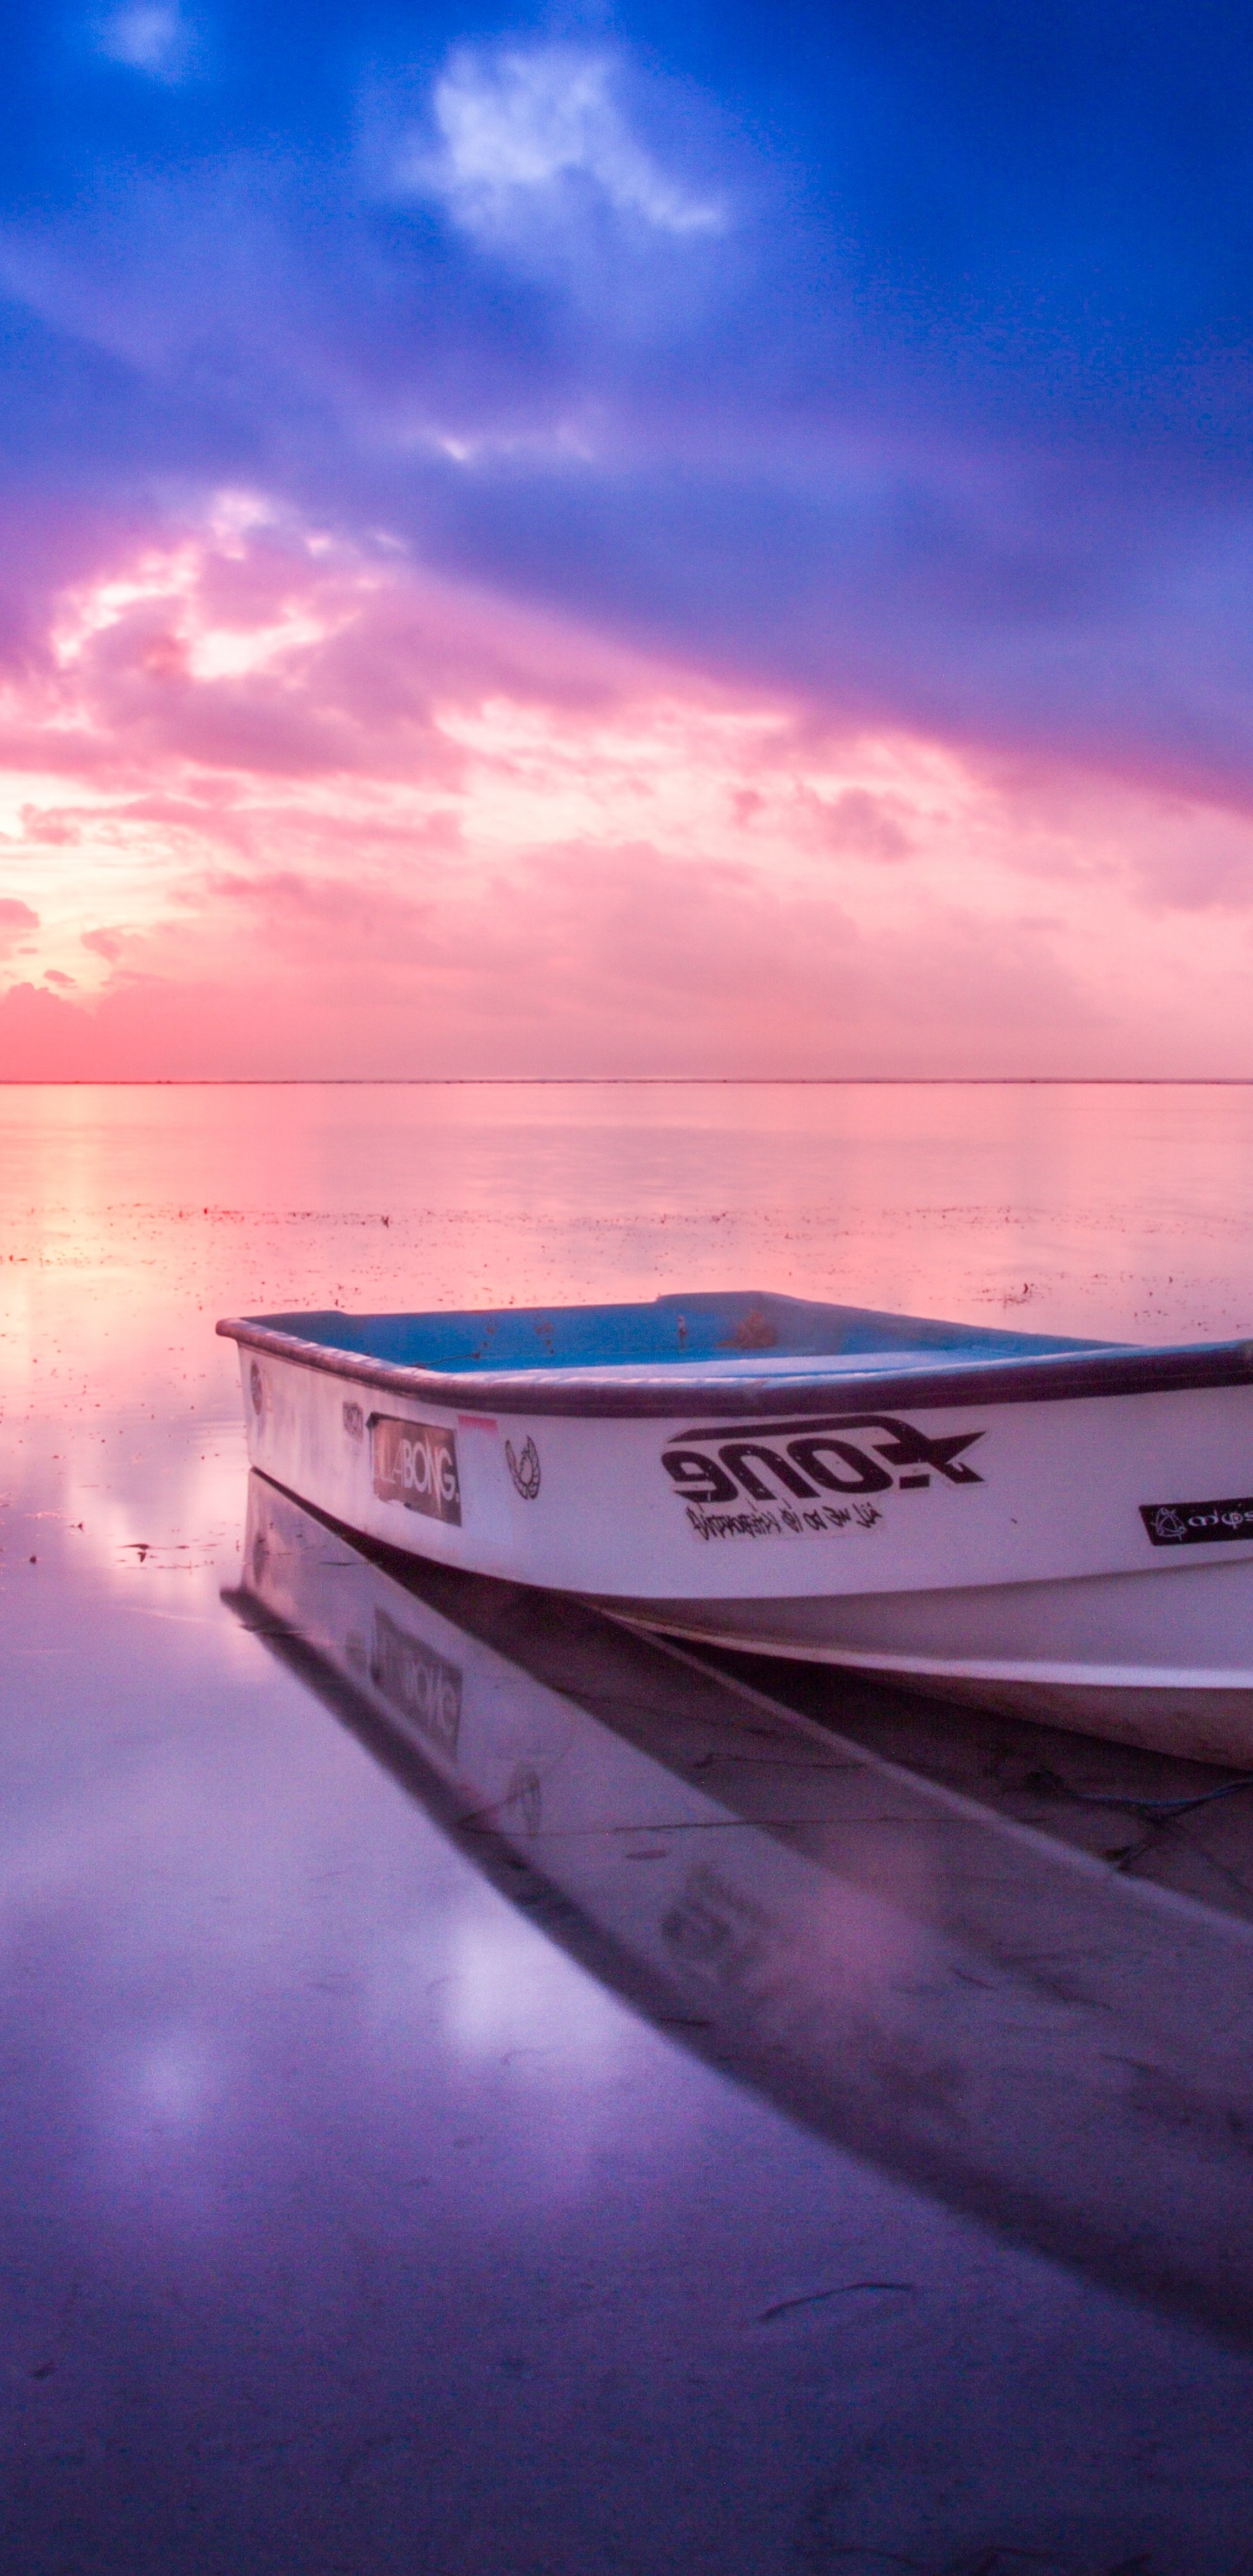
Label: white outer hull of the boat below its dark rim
xmin=220 ymin=1342 xmax=1253 ymax=1765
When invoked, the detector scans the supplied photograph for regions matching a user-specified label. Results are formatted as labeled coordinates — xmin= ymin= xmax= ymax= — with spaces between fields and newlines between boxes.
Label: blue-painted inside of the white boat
xmin=252 ymin=1288 xmax=1109 ymax=1376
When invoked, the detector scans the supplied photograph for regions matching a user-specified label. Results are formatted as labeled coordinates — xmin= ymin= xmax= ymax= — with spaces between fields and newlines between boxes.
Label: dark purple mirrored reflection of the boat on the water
xmin=230 ymin=1476 xmax=1253 ymax=2342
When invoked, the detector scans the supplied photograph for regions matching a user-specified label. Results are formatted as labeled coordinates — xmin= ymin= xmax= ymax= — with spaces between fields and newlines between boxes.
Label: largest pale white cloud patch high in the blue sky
xmin=410 ymin=46 xmax=727 ymax=245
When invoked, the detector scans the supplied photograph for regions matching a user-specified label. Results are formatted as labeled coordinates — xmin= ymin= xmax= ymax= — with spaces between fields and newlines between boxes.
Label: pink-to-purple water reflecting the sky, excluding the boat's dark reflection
xmin=0 ymin=1092 xmax=1250 ymax=2576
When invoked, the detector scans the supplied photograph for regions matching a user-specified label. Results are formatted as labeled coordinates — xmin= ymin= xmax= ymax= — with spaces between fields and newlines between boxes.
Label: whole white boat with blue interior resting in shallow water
xmin=217 ymin=1291 xmax=1253 ymax=1765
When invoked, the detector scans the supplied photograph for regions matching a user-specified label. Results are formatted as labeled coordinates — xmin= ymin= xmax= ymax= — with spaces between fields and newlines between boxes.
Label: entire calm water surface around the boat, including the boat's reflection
xmin=0 ymin=1087 xmax=1253 ymax=2576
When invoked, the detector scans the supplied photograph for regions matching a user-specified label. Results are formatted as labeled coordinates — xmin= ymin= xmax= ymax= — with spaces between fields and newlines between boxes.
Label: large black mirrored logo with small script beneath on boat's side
xmin=662 ymin=1414 xmax=982 ymax=1538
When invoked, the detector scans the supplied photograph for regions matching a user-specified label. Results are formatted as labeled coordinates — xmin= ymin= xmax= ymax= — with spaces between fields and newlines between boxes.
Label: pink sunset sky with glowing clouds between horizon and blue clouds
xmin=0 ymin=492 xmax=1253 ymax=1079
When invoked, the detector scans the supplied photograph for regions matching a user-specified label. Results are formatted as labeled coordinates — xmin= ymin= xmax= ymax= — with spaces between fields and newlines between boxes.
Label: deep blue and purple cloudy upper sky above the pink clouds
xmin=0 ymin=0 xmax=1253 ymax=1066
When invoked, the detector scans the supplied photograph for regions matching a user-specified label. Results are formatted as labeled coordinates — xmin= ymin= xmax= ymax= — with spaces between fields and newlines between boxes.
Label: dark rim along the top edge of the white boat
xmin=217 ymin=1317 xmax=1253 ymax=1422
